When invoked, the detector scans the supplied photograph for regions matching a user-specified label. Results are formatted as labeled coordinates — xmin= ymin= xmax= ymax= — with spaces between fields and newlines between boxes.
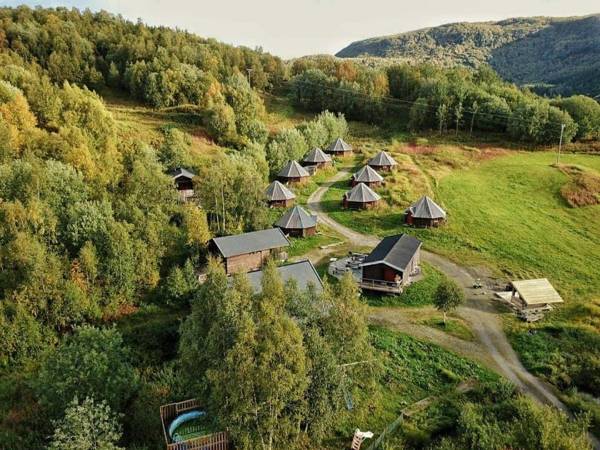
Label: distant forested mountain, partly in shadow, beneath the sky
xmin=336 ymin=14 xmax=600 ymax=95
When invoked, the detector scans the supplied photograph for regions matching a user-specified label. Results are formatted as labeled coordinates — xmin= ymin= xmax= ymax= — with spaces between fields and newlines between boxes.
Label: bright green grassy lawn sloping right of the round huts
xmin=324 ymin=153 xmax=600 ymax=301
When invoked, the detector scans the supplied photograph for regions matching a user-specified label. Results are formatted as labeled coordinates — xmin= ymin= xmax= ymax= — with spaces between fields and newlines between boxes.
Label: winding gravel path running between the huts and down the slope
xmin=307 ymin=170 xmax=600 ymax=449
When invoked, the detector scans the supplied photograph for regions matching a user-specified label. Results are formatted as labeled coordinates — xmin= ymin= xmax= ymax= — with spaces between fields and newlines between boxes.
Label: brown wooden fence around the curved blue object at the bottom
xmin=160 ymin=398 xmax=229 ymax=450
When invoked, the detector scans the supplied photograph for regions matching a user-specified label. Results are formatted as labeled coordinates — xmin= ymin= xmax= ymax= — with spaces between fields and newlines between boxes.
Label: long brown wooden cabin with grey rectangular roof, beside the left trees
xmin=208 ymin=228 xmax=290 ymax=275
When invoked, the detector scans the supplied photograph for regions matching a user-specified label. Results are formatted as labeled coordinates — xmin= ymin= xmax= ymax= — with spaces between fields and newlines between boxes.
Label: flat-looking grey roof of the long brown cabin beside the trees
xmin=212 ymin=228 xmax=290 ymax=258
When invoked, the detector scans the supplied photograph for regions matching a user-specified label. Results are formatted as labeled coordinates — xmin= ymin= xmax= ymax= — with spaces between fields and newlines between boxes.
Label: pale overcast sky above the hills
xmin=0 ymin=0 xmax=600 ymax=58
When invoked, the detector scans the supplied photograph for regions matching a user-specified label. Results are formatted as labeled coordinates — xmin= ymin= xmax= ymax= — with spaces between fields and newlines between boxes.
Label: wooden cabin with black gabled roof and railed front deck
xmin=360 ymin=234 xmax=422 ymax=293
